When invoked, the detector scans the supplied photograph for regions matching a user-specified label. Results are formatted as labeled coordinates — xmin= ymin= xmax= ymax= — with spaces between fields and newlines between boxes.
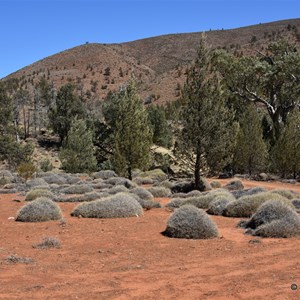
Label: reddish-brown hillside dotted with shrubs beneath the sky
xmin=2 ymin=19 xmax=300 ymax=103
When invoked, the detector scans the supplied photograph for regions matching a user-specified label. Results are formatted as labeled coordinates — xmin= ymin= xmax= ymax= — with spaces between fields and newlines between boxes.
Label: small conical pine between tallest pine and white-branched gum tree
xmin=234 ymin=104 xmax=268 ymax=175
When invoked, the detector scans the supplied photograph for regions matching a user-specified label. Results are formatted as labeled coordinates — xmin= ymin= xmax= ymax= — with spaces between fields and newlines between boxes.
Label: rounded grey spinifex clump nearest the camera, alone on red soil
xmin=162 ymin=205 xmax=218 ymax=239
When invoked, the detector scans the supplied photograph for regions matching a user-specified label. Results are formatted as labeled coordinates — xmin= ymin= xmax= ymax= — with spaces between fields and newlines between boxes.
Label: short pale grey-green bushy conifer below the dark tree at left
xmin=59 ymin=119 xmax=97 ymax=173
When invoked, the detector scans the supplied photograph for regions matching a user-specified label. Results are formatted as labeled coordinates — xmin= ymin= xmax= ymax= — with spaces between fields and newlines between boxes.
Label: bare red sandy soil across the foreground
xmin=0 ymin=181 xmax=300 ymax=300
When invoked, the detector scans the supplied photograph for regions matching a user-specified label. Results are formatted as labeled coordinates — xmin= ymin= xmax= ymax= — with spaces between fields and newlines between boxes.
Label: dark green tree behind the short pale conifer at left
xmin=49 ymin=84 xmax=85 ymax=142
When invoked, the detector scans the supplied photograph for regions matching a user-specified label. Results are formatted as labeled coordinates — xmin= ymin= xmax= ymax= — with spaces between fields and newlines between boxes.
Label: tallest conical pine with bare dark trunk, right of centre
xmin=178 ymin=37 xmax=235 ymax=190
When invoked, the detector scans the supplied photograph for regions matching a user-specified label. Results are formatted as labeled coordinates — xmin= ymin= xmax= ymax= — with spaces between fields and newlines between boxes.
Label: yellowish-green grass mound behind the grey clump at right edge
xmin=223 ymin=192 xmax=291 ymax=218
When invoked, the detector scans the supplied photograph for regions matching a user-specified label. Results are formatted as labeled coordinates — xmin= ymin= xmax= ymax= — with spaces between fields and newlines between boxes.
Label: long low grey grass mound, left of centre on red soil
xmin=71 ymin=193 xmax=143 ymax=218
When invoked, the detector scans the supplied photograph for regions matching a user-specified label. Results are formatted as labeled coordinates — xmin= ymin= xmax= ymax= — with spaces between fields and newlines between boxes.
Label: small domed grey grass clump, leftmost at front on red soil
xmin=16 ymin=197 xmax=62 ymax=222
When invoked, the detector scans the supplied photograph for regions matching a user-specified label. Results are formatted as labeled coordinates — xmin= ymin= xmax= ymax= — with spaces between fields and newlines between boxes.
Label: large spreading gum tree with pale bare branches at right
xmin=215 ymin=40 xmax=300 ymax=145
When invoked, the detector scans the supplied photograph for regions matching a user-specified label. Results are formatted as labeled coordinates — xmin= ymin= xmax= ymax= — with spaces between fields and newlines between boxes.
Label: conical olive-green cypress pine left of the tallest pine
xmin=114 ymin=80 xmax=152 ymax=179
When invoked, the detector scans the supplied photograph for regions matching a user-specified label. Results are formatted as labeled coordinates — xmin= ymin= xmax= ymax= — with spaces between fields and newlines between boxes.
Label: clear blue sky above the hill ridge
xmin=0 ymin=0 xmax=300 ymax=78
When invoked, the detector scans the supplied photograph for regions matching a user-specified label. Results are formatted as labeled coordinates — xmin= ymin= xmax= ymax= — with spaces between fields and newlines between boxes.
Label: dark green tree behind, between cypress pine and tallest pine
xmin=147 ymin=105 xmax=172 ymax=148
